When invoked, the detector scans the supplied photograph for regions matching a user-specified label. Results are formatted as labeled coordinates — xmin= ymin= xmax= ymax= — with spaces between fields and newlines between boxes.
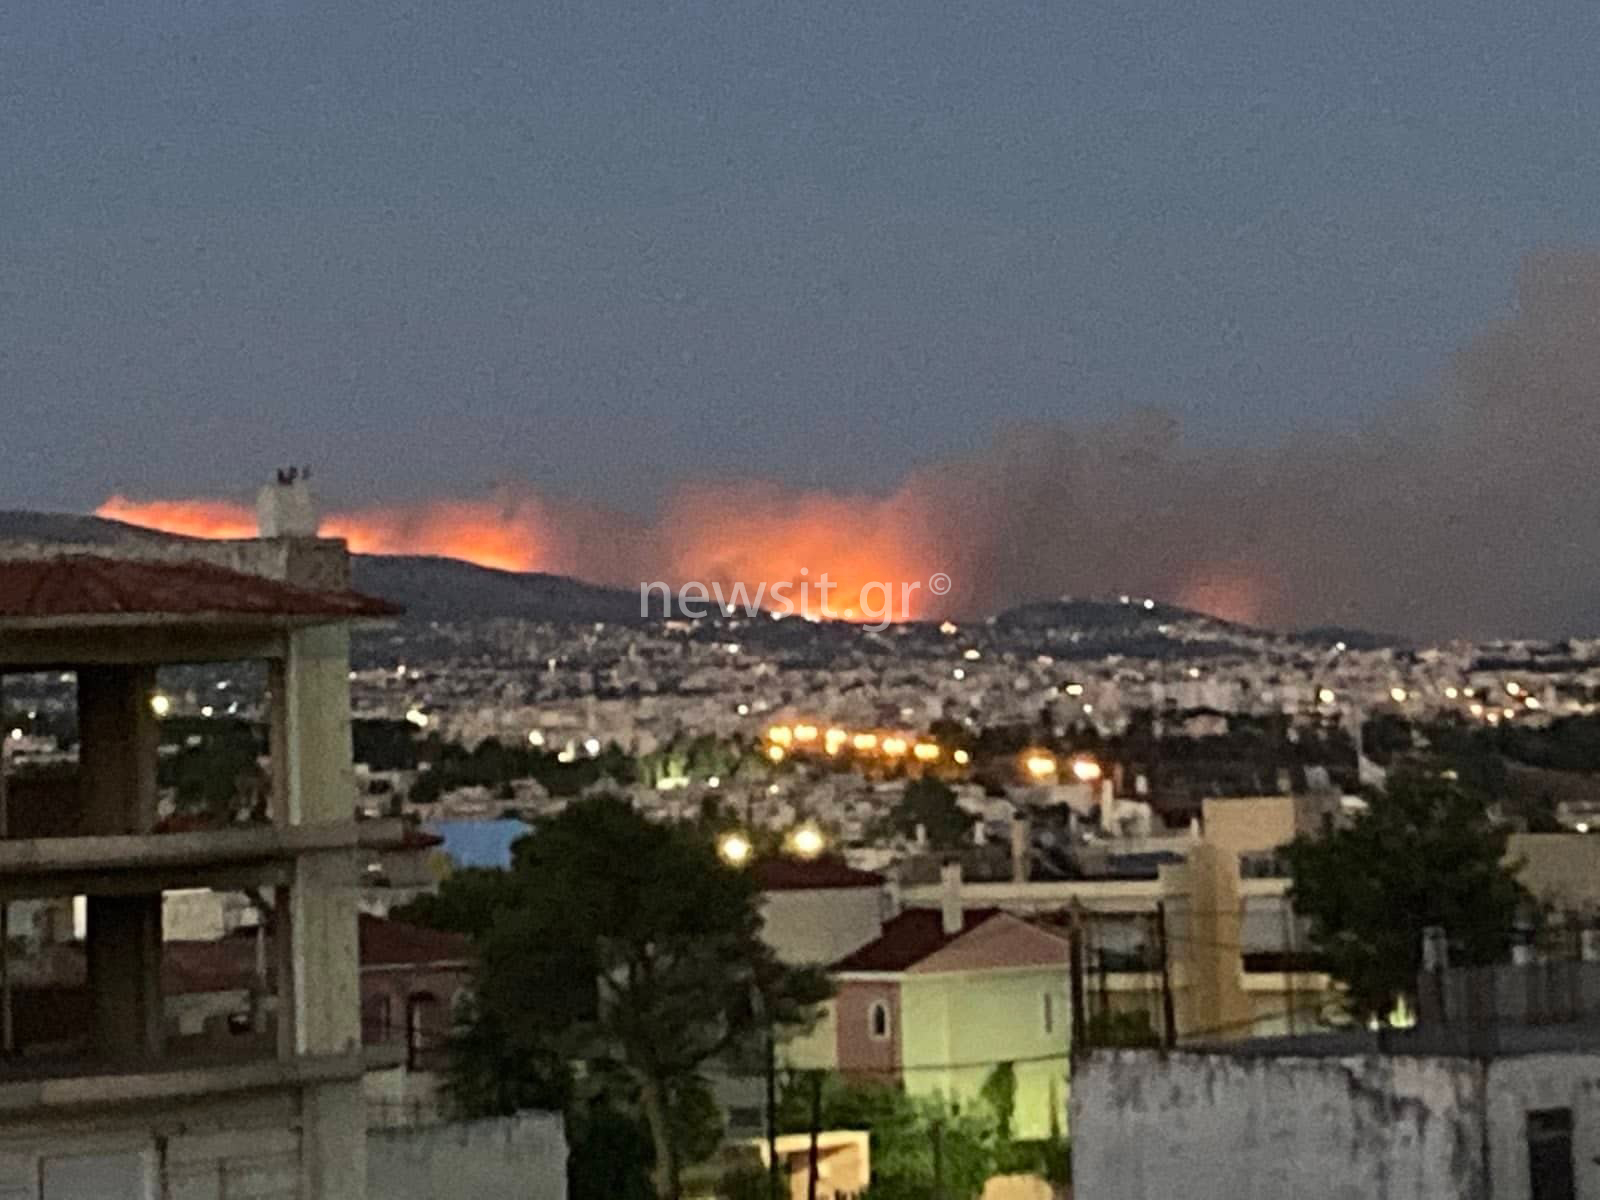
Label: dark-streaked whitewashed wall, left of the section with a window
xmin=1072 ymin=1051 xmax=1478 ymax=1200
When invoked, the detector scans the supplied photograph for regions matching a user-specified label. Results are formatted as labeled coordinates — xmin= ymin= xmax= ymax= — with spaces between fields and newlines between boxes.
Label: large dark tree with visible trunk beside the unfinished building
xmin=457 ymin=797 xmax=829 ymax=1200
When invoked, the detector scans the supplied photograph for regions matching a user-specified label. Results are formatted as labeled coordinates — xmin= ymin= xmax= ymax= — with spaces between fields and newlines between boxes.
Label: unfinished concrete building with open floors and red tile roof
xmin=0 ymin=477 xmax=398 ymax=1200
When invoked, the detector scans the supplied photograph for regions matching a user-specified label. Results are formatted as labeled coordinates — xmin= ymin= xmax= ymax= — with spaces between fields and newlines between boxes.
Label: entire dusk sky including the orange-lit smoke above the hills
xmin=9 ymin=3 xmax=1600 ymax=637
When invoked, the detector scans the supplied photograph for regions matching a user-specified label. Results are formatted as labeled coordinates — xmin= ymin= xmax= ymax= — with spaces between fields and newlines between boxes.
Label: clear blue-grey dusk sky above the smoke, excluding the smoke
xmin=0 ymin=0 xmax=1600 ymax=630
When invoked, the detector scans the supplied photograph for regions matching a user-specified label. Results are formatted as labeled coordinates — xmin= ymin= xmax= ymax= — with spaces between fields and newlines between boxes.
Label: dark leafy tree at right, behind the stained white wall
xmin=1285 ymin=771 xmax=1526 ymax=1022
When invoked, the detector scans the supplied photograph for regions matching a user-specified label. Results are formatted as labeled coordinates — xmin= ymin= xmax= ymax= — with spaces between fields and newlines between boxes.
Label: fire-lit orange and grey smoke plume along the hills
xmin=99 ymin=250 xmax=1600 ymax=638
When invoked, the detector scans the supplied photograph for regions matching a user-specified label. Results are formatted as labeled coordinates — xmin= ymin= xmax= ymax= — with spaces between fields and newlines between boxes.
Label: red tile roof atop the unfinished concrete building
xmin=0 ymin=554 xmax=400 ymax=619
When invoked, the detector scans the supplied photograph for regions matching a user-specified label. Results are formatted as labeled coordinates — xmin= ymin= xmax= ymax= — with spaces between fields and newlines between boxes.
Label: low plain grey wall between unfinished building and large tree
xmin=366 ymin=1112 xmax=566 ymax=1200
